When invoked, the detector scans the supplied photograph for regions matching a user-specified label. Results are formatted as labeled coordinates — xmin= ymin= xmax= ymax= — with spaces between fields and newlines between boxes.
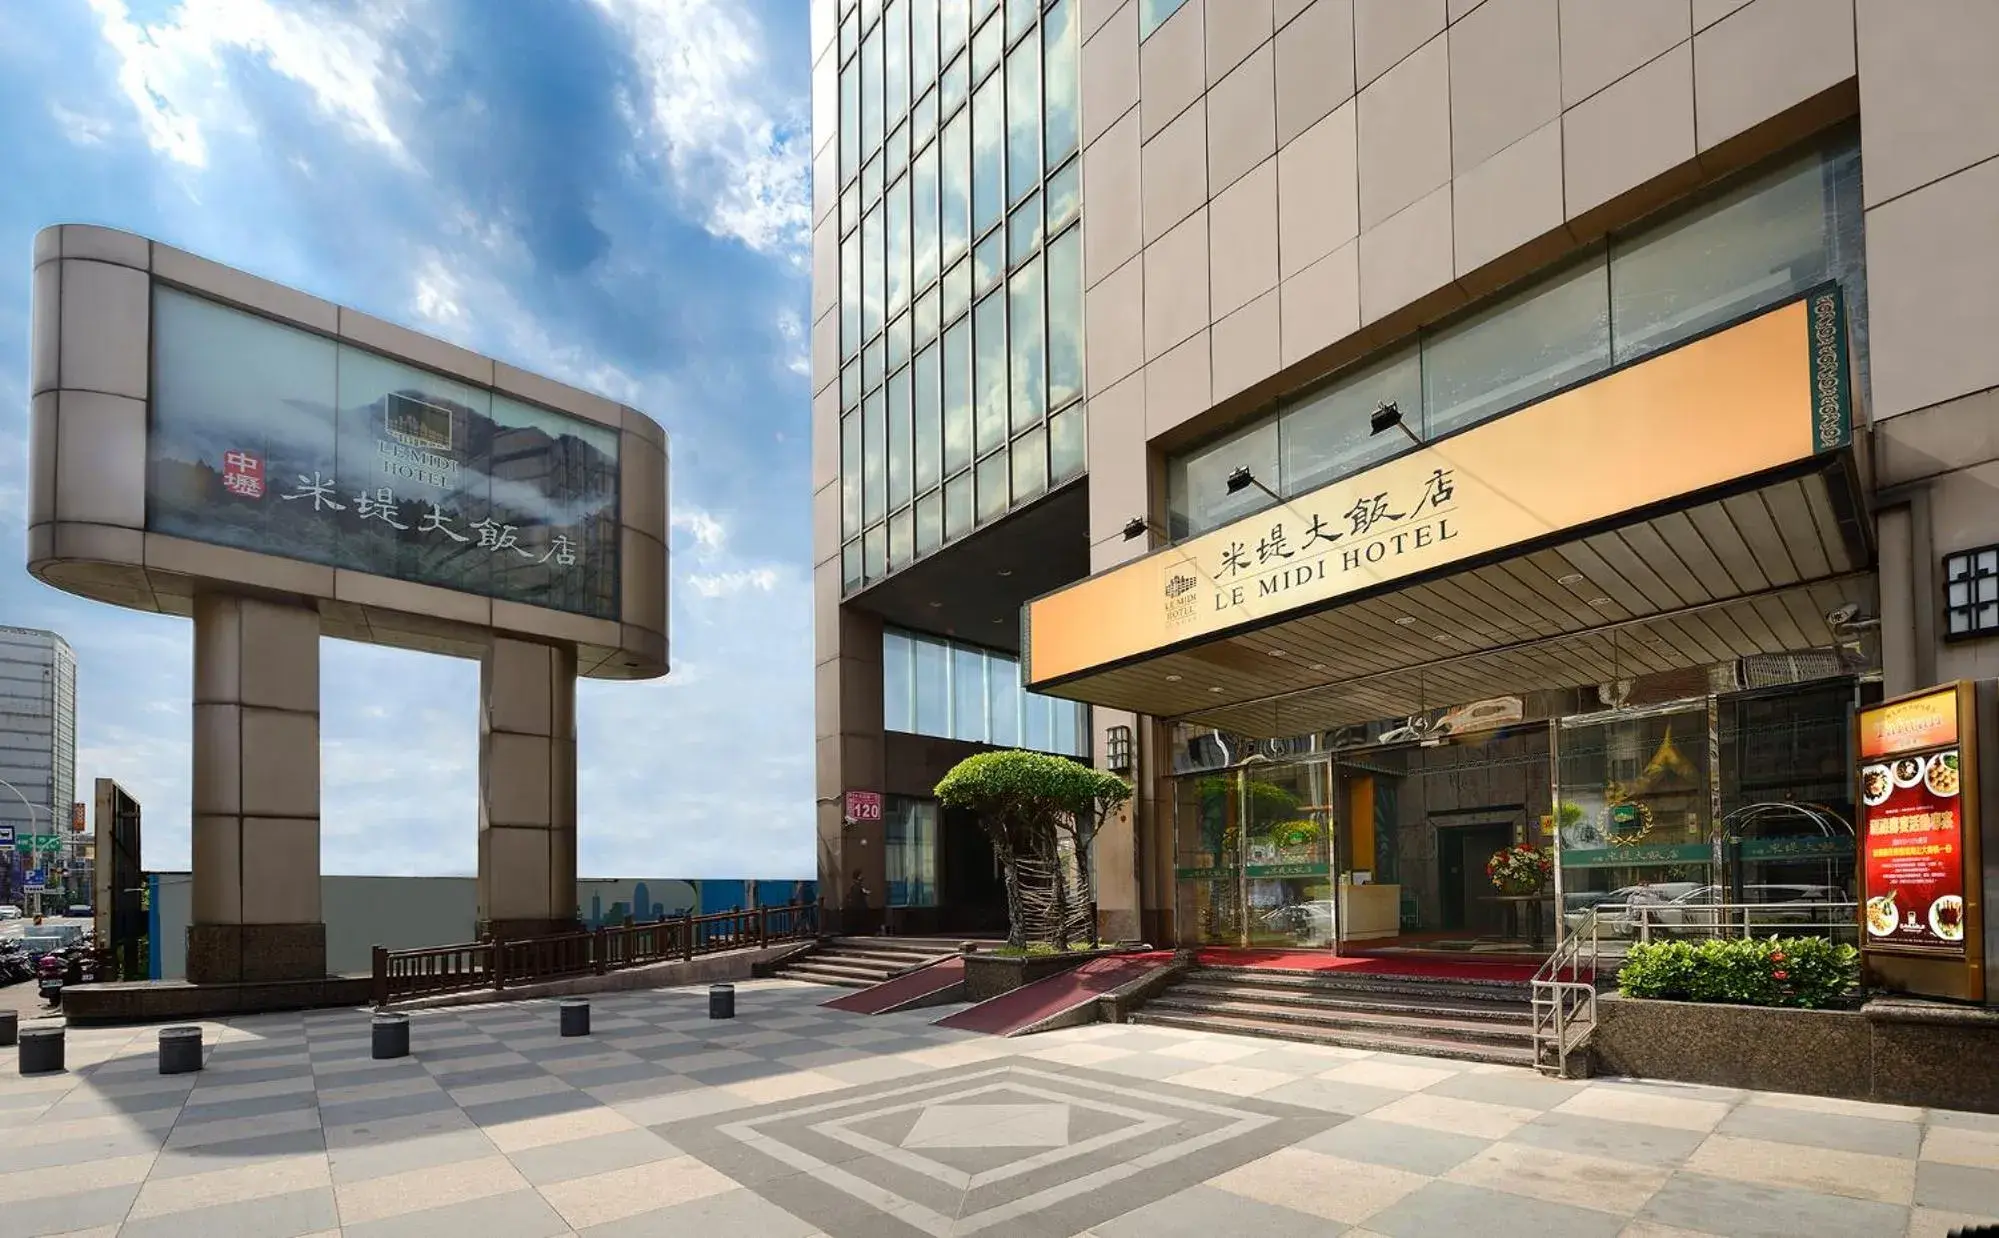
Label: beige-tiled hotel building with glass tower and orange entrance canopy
xmin=812 ymin=0 xmax=1999 ymax=992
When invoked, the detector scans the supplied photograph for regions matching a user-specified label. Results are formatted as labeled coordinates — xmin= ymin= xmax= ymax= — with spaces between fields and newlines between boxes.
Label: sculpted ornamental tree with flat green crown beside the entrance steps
xmin=936 ymin=750 xmax=1131 ymax=950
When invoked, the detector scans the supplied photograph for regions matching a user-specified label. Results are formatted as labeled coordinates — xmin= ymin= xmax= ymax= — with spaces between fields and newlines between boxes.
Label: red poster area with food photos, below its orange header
xmin=1859 ymin=748 xmax=1965 ymax=954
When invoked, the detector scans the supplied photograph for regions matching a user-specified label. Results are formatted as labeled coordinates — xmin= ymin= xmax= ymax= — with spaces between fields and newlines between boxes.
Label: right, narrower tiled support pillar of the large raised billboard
xmin=480 ymin=634 xmax=578 ymax=938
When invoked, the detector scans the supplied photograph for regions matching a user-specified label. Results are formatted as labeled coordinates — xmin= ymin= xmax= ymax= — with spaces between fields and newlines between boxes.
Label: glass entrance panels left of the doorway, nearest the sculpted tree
xmin=1173 ymin=762 xmax=1335 ymax=948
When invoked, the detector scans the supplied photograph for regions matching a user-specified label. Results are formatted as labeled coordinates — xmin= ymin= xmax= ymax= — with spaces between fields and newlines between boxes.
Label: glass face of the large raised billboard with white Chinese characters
xmin=146 ymin=286 xmax=620 ymax=620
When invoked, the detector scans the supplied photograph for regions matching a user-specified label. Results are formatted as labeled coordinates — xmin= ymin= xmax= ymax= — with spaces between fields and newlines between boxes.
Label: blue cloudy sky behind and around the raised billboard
xmin=0 ymin=0 xmax=812 ymax=878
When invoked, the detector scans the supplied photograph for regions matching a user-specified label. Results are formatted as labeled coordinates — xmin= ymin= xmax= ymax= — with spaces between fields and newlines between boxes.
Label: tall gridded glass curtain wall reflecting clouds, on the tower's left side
xmin=838 ymin=0 xmax=1087 ymax=592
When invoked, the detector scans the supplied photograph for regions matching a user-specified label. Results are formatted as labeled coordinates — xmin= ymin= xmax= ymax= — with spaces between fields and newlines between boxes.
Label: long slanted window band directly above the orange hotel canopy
xmin=1167 ymin=140 xmax=1867 ymax=538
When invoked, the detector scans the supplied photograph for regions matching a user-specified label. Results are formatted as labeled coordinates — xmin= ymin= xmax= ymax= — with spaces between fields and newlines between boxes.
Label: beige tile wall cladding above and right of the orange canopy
xmin=816 ymin=0 xmax=1999 ymax=940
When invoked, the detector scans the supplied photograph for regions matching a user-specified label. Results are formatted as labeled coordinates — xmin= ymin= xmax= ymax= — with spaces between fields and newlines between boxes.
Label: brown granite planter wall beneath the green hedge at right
xmin=1589 ymin=996 xmax=1999 ymax=1112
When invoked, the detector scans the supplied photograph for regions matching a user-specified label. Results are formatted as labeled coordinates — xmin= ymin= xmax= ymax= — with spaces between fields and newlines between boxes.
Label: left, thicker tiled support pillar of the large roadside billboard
xmin=188 ymin=594 xmax=326 ymax=984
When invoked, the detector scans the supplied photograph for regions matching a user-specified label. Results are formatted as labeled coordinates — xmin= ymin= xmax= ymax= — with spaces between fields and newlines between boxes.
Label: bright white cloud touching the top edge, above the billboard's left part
xmin=90 ymin=0 xmax=410 ymax=168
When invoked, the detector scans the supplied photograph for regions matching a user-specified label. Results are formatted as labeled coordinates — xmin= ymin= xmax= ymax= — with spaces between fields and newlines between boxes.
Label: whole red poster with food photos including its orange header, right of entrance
xmin=1859 ymin=690 xmax=1967 ymax=958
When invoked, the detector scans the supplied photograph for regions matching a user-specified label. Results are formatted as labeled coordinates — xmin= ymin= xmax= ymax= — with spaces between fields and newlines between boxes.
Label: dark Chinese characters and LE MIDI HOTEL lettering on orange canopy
xmin=1165 ymin=468 xmax=1457 ymax=626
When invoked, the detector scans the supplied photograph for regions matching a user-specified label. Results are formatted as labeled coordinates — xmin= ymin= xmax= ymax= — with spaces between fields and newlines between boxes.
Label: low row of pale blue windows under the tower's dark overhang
xmin=882 ymin=628 xmax=1089 ymax=758
